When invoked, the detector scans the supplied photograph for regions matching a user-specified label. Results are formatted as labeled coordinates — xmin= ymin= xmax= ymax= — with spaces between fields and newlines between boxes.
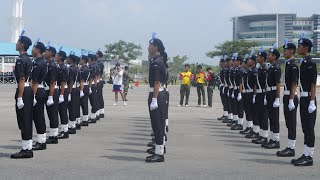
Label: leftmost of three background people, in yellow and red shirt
xmin=178 ymin=64 xmax=192 ymax=107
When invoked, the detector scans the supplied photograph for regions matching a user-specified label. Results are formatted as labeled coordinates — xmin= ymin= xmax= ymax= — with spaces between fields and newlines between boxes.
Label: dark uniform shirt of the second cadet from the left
xmin=32 ymin=57 xmax=48 ymax=84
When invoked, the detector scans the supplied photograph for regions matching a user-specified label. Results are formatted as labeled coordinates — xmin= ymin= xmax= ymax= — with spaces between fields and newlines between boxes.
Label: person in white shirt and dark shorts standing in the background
xmin=113 ymin=63 xmax=127 ymax=106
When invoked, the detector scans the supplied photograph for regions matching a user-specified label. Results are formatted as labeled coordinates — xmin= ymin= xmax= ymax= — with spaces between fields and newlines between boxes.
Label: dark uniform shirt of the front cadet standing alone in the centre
xmin=149 ymin=55 xmax=166 ymax=87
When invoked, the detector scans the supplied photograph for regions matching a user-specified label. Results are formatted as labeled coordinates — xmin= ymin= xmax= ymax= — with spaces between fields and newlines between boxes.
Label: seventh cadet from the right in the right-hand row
xmin=231 ymin=53 xmax=243 ymax=130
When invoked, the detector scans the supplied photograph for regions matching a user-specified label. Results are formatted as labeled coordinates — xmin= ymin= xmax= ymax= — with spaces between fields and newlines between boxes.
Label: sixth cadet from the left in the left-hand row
xmin=80 ymin=55 xmax=90 ymax=126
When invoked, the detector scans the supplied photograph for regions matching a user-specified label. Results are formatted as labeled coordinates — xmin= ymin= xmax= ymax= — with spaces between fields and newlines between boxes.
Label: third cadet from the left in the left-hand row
xmin=44 ymin=45 xmax=59 ymax=144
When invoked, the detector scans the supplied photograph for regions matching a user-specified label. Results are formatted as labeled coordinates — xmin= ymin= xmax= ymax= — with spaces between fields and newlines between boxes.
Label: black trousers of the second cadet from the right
xmin=283 ymin=95 xmax=299 ymax=140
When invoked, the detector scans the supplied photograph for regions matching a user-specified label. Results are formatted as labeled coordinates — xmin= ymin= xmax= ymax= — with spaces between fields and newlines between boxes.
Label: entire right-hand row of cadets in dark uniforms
xmin=218 ymin=37 xmax=317 ymax=166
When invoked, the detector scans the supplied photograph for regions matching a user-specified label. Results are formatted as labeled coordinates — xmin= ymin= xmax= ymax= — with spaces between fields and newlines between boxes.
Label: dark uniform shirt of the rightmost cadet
xmin=300 ymin=56 xmax=317 ymax=92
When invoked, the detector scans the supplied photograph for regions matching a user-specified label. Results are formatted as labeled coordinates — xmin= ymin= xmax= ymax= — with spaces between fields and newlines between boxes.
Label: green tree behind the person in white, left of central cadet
xmin=105 ymin=40 xmax=142 ymax=64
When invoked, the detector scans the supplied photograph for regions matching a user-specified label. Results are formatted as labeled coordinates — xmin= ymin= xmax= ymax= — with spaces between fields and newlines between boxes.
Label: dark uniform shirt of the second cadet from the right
xmin=284 ymin=59 xmax=299 ymax=91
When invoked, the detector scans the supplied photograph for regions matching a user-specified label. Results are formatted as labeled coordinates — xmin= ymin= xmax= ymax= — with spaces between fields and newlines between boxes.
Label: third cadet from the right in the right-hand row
xmin=262 ymin=45 xmax=281 ymax=149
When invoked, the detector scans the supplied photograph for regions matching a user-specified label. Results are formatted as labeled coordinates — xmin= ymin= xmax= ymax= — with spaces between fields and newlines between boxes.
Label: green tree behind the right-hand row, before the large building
xmin=206 ymin=40 xmax=258 ymax=58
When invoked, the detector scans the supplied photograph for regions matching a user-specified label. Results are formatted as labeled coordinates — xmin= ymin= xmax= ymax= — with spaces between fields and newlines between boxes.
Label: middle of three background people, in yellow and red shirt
xmin=196 ymin=65 xmax=207 ymax=107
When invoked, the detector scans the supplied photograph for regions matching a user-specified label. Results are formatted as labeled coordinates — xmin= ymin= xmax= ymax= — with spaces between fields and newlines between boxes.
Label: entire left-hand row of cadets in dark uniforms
xmin=11 ymin=32 xmax=104 ymax=159
